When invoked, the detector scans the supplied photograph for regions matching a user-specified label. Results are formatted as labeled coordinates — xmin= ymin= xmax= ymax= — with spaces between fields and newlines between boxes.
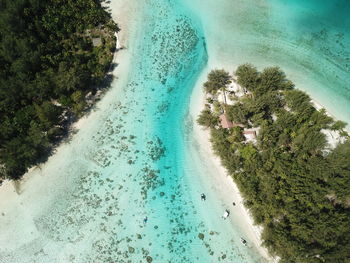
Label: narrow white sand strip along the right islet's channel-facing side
xmin=189 ymin=65 xmax=278 ymax=262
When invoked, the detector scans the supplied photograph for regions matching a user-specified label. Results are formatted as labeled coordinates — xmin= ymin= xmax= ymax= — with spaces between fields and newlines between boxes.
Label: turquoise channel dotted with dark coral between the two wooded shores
xmin=0 ymin=0 xmax=260 ymax=263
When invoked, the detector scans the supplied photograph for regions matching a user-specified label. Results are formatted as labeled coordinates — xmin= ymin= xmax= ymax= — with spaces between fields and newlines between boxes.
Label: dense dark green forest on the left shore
xmin=0 ymin=0 xmax=118 ymax=181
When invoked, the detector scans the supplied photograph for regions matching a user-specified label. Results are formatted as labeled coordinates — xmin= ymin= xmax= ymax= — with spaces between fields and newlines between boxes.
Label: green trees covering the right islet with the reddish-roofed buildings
xmin=198 ymin=64 xmax=350 ymax=263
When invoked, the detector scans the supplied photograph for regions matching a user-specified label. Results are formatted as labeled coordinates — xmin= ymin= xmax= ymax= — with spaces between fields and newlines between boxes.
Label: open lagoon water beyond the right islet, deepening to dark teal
xmin=184 ymin=0 xmax=350 ymax=123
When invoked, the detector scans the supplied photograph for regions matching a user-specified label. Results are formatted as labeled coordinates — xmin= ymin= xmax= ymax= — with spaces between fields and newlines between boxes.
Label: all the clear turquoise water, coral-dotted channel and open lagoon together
xmin=0 ymin=0 xmax=350 ymax=263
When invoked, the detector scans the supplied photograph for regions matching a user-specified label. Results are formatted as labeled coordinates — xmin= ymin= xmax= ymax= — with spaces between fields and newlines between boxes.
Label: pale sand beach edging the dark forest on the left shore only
xmin=0 ymin=0 xmax=142 ymax=251
